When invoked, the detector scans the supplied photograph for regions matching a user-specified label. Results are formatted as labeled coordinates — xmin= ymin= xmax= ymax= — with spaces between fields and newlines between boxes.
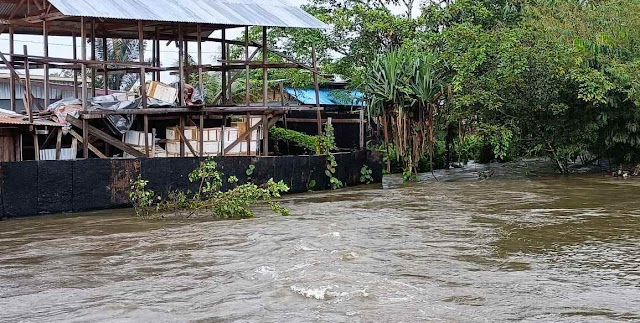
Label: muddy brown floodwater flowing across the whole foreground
xmin=0 ymin=163 xmax=640 ymax=322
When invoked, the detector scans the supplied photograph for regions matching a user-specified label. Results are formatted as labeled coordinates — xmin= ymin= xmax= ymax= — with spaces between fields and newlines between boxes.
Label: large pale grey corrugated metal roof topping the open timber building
xmin=49 ymin=0 xmax=327 ymax=29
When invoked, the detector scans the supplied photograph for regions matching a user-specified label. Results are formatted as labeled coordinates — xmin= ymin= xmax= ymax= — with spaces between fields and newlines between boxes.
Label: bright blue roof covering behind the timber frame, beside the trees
xmin=284 ymin=87 xmax=367 ymax=107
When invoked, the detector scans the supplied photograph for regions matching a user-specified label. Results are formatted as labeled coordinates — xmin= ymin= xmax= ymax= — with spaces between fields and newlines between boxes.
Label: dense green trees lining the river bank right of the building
xmin=252 ymin=0 xmax=640 ymax=177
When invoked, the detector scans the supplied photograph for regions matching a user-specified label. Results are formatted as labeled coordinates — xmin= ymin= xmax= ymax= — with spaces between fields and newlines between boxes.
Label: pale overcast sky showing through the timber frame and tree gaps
xmin=0 ymin=0 xmax=420 ymax=80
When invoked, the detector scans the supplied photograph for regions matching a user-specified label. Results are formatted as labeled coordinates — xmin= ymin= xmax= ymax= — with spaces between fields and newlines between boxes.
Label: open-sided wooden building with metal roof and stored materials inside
xmin=0 ymin=0 xmax=364 ymax=161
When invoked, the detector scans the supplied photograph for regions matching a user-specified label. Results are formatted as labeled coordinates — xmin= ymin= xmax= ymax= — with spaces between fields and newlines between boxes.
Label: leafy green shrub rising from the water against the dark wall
xmin=129 ymin=159 xmax=289 ymax=219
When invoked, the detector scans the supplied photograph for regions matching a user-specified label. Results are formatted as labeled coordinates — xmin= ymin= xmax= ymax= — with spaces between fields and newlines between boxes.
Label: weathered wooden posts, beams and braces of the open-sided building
xmin=0 ymin=0 xmax=363 ymax=158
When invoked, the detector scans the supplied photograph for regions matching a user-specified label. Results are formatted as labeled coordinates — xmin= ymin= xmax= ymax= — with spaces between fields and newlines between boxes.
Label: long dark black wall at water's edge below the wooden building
xmin=0 ymin=150 xmax=382 ymax=218
